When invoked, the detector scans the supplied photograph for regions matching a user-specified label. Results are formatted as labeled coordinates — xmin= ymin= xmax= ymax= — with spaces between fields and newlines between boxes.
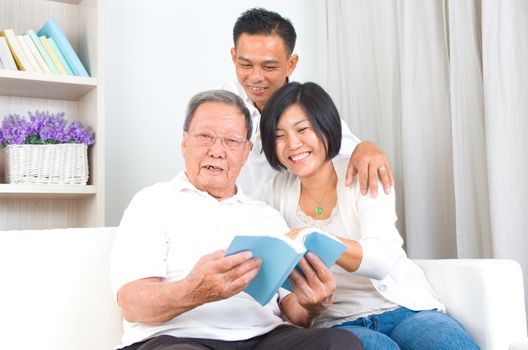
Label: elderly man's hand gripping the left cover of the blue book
xmin=186 ymin=250 xmax=261 ymax=304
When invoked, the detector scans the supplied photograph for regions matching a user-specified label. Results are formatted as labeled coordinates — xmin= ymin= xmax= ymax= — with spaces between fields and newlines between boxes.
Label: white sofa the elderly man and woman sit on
xmin=0 ymin=228 xmax=528 ymax=350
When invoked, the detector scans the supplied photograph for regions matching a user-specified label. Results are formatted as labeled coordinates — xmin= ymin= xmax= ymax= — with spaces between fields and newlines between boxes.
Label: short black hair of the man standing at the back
xmin=233 ymin=7 xmax=297 ymax=55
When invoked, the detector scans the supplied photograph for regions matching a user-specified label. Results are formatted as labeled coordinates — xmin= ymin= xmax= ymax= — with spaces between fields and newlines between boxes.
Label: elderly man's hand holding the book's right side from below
xmin=288 ymin=253 xmax=336 ymax=318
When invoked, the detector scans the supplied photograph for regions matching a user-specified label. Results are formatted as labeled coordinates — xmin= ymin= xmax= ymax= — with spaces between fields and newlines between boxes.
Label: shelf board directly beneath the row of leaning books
xmin=0 ymin=69 xmax=97 ymax=101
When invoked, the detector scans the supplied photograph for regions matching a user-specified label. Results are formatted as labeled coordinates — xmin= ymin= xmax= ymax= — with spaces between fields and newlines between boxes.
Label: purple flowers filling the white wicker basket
xmin=0 ymin=111 xmax=95 ymax=147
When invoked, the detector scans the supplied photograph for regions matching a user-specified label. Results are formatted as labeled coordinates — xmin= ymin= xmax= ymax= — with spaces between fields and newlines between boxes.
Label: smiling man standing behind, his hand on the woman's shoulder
xmin=224 ymin=8 xmax=394 ymax=197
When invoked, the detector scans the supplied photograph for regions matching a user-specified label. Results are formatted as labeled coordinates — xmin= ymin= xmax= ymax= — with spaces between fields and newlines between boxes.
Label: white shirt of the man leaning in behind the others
xmin=222 ymin=81 xmax=361 ymax=198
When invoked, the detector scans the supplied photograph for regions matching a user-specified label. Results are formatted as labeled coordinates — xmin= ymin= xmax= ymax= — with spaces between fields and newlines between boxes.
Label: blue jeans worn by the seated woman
xmin=333 ymin=307 xmax=480 ymax=350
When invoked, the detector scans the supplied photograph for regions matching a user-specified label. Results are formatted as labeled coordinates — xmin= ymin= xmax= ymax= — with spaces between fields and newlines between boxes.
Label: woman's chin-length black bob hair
xmin=260 ymin=82 xmax=341 ymax=170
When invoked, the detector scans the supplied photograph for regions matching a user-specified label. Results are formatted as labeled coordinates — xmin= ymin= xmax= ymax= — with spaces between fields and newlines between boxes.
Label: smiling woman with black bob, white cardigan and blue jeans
xmin=260 ymin=83 xmax=479 ymax=350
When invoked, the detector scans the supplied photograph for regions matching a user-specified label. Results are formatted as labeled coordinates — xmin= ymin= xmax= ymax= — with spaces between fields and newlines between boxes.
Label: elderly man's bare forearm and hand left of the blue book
xmin=117 ymin=250 xmax=261 ymax=325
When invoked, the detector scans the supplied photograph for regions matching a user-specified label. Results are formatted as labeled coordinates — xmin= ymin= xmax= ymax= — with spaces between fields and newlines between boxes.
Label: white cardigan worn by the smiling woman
xmin=261 ymin=158 xmax=449 ymax=311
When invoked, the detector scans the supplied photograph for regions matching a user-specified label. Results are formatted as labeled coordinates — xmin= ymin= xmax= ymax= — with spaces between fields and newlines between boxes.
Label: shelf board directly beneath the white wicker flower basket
xmin=0 ymin=184 xmax=97 ymax=199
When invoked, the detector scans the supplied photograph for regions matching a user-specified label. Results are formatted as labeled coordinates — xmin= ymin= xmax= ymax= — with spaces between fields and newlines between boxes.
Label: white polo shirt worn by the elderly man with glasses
xmin=111 ymin=172 xmax=289 ymax=346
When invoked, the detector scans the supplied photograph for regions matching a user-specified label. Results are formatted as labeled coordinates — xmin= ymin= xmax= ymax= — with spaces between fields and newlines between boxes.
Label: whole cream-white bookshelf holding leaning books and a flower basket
xmin=0 ymin=0 xmax=105 ymax=230
